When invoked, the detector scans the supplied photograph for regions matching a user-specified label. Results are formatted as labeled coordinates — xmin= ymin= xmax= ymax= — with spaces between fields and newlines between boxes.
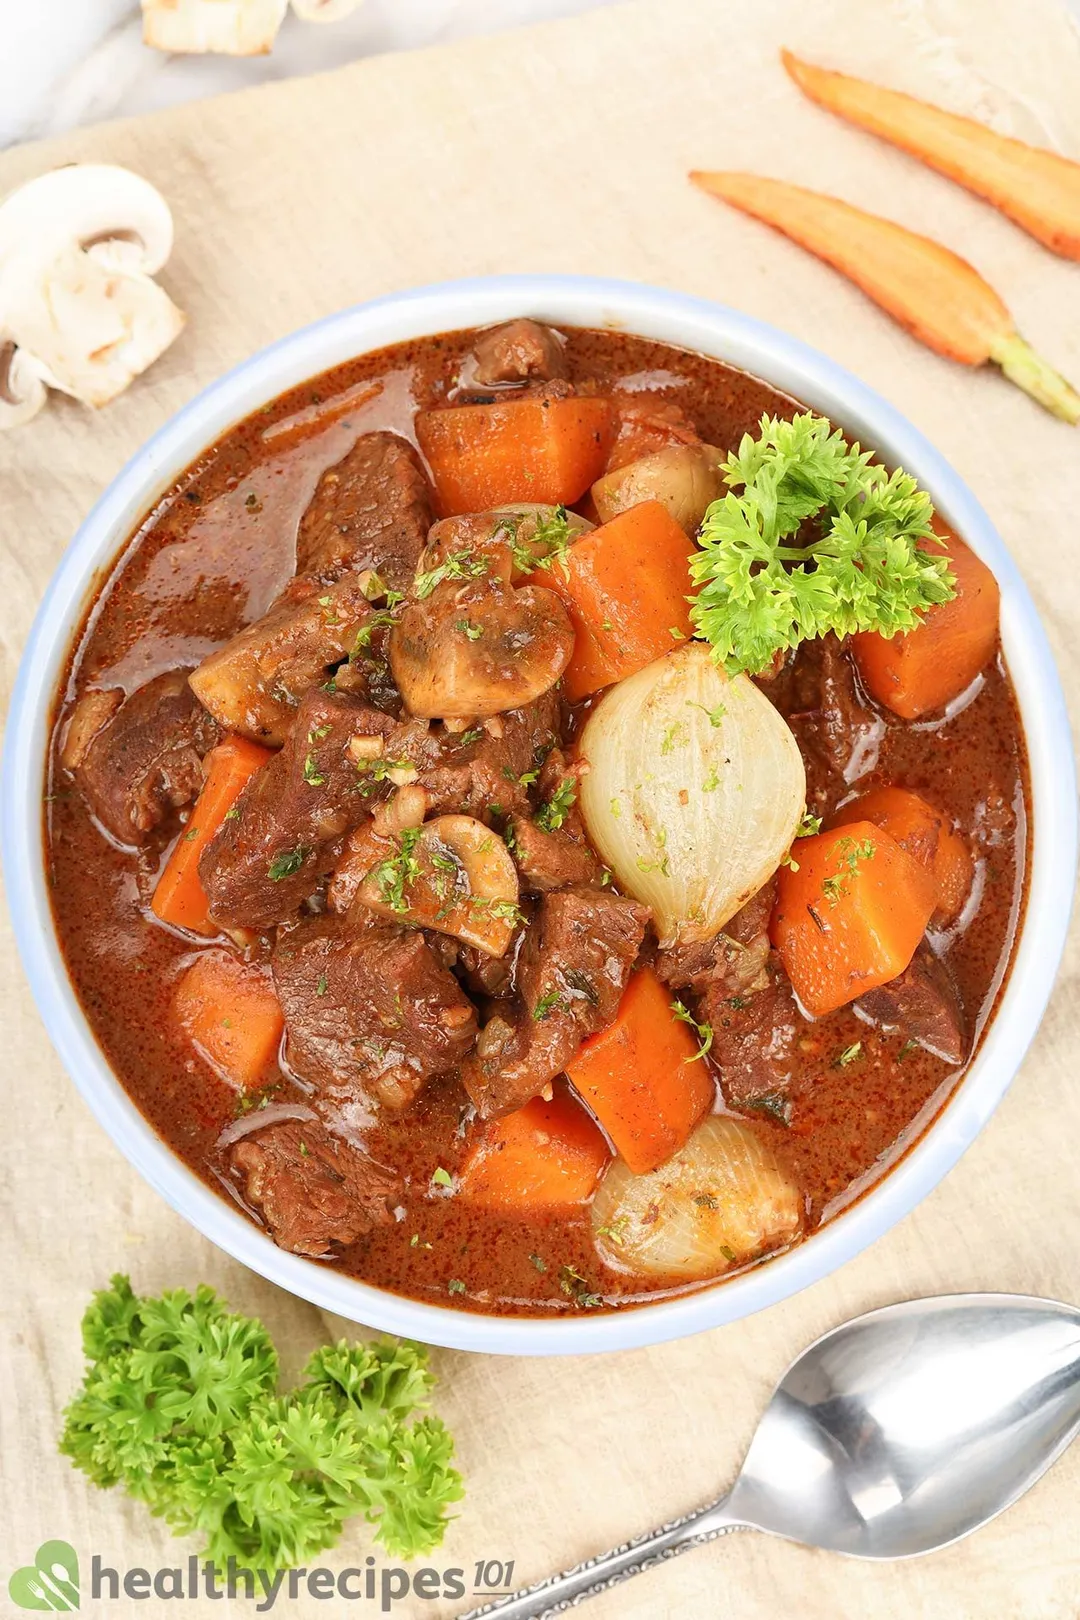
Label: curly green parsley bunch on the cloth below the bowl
xmin=60 ymin=1277 xmax=461 ymax=1575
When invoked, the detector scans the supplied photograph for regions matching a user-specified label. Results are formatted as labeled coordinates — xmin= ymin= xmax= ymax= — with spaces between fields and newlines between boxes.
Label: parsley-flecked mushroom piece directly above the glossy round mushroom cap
xmin=416 ymin=501 xmax=593 ymax=585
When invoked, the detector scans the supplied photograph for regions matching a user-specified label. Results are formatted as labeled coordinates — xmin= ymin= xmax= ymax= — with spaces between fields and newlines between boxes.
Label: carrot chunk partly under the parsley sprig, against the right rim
xmin=852 ymin=518 xmax=1001 ymax=719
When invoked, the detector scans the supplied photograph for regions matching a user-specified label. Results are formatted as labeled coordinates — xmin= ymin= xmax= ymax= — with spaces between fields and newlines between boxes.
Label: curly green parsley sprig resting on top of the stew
xmin=691 ymin=411 xmax=955 ymax=676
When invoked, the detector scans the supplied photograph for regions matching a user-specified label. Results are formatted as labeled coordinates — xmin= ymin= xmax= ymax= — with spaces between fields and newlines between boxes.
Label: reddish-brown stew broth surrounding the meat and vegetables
xmin=47 ymin=330 xmax=1028 ymax=1314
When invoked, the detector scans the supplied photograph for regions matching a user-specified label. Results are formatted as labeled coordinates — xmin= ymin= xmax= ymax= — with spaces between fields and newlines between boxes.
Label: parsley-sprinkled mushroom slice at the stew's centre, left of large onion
xmin=356 ymin=815 xmax=520 ymax=956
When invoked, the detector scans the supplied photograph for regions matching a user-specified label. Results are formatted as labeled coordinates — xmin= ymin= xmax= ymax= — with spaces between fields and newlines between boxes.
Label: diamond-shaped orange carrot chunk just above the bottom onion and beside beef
xmin=567 ymin=967 xmax=716 ymax=1176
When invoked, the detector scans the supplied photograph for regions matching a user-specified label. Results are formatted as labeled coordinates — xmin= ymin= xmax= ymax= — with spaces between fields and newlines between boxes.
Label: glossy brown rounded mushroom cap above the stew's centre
xmin=389 ymin=580 xmax=573 ymax=719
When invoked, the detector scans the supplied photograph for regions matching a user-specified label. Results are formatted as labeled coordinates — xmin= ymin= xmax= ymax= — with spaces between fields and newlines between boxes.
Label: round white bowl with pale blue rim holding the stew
xmin=0 ymin=275 xmax=1077 ymax=1356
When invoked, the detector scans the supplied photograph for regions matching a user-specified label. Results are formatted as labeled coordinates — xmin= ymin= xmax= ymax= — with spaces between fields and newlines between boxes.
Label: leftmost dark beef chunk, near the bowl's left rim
xmin=68 ymin=669 xmax=219 ymax=844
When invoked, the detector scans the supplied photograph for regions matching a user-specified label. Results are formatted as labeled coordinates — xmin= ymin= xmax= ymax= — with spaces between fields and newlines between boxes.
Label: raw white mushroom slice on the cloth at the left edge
xmin=0 ymin=164 xmax=185 ymax=428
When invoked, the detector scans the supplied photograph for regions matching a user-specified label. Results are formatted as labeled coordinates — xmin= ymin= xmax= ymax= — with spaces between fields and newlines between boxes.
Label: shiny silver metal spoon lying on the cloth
xmin=465 ymin=1294 xmax=1080 ymax=1620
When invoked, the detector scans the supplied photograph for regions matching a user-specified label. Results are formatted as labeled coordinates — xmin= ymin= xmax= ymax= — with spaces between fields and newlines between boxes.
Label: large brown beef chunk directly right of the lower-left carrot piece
xmin=272 ymin=910 xmax=476 ymax=1108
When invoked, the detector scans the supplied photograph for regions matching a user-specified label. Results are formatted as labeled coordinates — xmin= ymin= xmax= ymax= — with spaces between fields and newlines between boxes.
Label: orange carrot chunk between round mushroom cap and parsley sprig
xmin=531 ymin=501 xmax=695 ymax=703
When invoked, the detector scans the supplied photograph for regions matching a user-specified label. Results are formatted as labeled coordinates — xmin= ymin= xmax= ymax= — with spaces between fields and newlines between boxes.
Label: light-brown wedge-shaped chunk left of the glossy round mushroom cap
xmin=191 ymin=573 xmax=378 ymax=745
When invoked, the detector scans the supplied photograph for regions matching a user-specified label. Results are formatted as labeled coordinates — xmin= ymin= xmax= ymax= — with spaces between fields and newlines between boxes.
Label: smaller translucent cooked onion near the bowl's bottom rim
xmin=593 ymin=1115 xmax=803 ymax=1277
